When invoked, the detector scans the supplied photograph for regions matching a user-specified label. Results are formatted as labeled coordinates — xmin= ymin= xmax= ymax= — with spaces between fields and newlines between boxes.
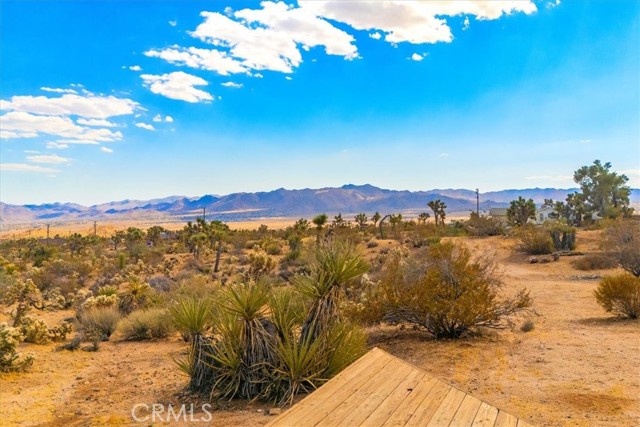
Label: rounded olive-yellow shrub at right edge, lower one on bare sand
xmin=593 ymin=273 xmax=640 ymax=319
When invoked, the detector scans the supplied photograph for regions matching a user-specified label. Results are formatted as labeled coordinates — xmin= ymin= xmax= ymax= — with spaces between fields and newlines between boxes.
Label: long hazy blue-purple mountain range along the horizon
xmin=0 ymin=184 xmax=640 ymax=228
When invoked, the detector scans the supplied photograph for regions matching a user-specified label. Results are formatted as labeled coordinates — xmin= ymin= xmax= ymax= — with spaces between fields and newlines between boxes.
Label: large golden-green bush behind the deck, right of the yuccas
xmin=365 ymin=242 xmax=532 ymax=338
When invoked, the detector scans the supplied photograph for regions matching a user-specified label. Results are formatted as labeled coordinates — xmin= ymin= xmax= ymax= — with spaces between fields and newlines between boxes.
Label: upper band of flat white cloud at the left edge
xmin=0 ymin=94 xmax=139 ymax=119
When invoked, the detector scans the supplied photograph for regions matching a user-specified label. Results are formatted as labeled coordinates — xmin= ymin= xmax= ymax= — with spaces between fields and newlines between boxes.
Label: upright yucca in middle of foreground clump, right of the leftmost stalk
xmin=211 ymin=283 xmax=278 ymax=399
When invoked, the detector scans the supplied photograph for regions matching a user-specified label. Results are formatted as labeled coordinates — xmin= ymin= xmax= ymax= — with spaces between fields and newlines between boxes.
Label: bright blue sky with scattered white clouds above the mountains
xmin=0 ymin=0 xmax=640 ymax=204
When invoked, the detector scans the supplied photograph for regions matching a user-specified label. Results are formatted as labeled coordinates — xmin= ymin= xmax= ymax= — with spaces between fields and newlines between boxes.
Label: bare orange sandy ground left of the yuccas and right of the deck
xmin=0 ymin=232 xmax=640 ymax=427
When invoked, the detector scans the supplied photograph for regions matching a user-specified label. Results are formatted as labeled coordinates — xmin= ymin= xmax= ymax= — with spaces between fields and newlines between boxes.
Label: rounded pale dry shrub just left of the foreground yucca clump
xmin=118 ymin=308 xmax=173 ymax=341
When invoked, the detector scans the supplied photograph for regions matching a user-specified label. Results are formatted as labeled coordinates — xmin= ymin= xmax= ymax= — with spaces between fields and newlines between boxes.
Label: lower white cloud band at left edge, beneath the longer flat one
xmin=0 ymin=111 xmax=122 ymax=141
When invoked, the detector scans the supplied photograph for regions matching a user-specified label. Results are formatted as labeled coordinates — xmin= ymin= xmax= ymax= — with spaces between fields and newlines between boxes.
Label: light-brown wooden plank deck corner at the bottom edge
xmin=268 ymin=348 xmax=530 ymax=427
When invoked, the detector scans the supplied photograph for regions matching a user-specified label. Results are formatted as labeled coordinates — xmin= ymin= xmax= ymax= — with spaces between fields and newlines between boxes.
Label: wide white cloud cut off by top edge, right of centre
xmin=298 ymin=0 xmax=536 ymax=44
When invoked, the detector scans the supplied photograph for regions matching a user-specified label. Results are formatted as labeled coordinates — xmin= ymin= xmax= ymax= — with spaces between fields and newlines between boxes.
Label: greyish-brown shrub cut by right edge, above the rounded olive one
xmin=602 ymin=219 xmax=640 ymax=277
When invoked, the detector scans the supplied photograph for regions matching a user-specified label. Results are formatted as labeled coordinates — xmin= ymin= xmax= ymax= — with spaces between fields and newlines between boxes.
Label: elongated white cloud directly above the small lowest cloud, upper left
xmin=144 ymin=46 xmax=248 ymax=76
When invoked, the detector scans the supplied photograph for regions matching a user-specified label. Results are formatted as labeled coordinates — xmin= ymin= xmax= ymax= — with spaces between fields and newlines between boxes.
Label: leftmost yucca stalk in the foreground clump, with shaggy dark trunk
xmin=169 ymin=297 xmax=214 ymax=393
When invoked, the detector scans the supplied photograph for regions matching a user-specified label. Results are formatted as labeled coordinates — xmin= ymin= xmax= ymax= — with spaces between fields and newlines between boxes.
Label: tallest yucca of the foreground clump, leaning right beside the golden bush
xmin=293 ymin=241 xmax=369 ymax=342
